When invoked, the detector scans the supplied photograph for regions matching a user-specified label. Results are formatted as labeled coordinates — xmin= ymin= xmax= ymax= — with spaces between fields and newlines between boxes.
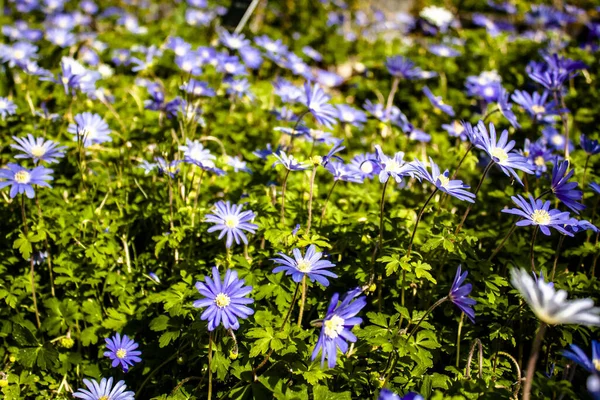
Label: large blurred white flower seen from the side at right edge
xmin=510 ymin=269 xmax=600 ymax=326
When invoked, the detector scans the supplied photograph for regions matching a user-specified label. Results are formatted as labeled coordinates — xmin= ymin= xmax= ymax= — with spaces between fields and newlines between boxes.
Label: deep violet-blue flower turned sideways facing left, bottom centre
xmin=311 ymin=289 xmax=367 ymax=368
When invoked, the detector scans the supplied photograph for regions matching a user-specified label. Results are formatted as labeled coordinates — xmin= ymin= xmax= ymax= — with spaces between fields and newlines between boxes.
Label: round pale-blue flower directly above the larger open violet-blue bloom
xmin=205 ymin=201 xmax=258 ymax=248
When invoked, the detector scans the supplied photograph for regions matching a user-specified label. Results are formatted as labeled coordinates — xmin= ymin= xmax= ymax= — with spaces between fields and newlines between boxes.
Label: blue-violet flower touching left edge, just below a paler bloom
xmin=0 ymin=163 xmax=53 ymax=199
